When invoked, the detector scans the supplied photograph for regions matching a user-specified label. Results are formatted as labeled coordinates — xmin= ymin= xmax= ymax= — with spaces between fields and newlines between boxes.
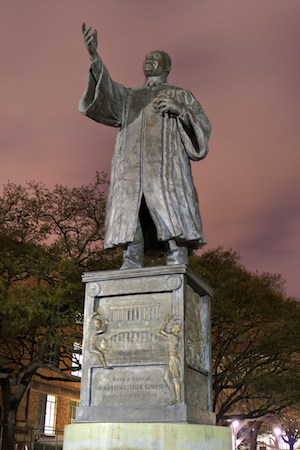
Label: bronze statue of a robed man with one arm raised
xmin=79 ymin=24 xmax=211 ymax=269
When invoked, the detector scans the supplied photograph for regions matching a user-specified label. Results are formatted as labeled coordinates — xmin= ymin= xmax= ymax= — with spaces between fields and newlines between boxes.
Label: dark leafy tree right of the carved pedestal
xmin=190 ymin=248 xmax=300 ymax=424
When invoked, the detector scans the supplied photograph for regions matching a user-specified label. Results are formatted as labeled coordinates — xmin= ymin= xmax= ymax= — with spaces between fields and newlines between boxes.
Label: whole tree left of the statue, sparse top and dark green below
xmin=0 ymin=174 xmax=119 ymax=450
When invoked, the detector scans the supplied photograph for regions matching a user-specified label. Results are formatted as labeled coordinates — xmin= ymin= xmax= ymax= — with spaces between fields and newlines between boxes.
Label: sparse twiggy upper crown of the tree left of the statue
xmin=0 ymin=173 xmax=107 ymax=259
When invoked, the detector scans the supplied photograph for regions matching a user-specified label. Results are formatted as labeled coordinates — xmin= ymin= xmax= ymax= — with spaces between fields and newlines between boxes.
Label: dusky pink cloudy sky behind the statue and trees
xmin=0 ymin=0 xmax=300 ymax=298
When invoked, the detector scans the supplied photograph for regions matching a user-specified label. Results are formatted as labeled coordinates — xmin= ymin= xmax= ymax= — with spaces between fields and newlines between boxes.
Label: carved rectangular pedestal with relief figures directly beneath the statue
xmin=75 ymin=265 xmax=216 ymax=426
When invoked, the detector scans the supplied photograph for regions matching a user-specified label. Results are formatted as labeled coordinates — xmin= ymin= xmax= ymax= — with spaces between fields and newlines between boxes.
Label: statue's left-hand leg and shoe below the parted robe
xmin=120 ymin=218 xmax=144 ymax=269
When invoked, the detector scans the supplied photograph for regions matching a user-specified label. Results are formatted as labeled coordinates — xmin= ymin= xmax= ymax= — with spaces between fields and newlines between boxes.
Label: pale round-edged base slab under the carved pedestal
xmin=63 ymin=423 xmax=232 ymax=450
